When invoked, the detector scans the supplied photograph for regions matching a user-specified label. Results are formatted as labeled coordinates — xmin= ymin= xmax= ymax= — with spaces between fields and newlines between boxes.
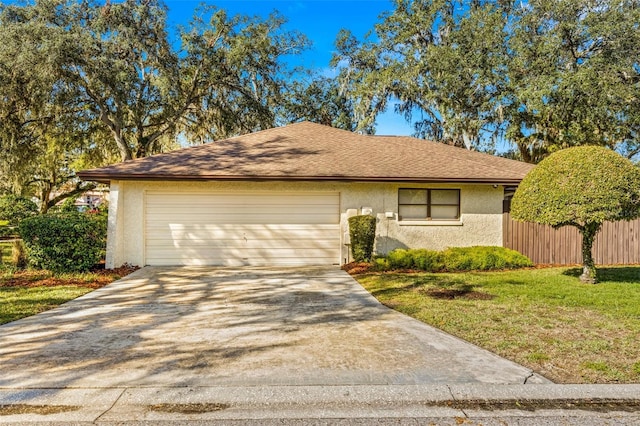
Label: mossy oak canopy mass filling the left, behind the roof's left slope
xmin=0 ymin=0 xmax=309 ymax=209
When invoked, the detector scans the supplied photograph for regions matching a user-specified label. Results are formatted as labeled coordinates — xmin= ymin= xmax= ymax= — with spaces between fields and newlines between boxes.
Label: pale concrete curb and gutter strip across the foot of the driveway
xmin=0 ymin=384 xmax=640 ymax=424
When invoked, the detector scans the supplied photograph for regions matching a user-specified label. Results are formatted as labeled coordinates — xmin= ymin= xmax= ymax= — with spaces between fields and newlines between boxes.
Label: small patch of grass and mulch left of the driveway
xmin=0 ymin=267 xmax=136 ymax=324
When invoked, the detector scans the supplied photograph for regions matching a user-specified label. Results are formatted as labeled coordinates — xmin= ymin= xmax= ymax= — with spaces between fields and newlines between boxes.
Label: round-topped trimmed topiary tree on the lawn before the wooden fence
xmin=511 ymin=146 xmax=640 ymax=283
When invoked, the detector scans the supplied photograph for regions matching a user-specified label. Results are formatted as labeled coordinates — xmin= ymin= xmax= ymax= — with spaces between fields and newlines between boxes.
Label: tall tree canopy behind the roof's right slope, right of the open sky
xmin=333 ymin=0 xmax=507 ymax=148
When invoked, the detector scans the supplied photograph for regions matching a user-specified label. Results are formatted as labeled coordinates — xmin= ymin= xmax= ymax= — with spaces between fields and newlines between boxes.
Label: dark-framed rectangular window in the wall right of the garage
xmin=398 ymin=188 xmax=460 ymax=220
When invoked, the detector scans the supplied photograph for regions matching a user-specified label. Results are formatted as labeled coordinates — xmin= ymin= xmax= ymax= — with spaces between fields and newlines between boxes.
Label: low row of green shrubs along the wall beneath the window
xmin=375 ymin=246 xmax=533 ymax=272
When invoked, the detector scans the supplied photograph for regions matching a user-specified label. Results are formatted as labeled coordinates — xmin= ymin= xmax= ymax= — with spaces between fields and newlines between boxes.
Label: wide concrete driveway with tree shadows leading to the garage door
xmin=0 ymin=267 xmax=546 ymax=389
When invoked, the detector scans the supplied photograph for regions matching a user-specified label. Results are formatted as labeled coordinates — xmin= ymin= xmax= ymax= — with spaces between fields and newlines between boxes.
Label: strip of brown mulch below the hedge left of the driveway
xmin=0 ymin=265 xmax=139 ymax=289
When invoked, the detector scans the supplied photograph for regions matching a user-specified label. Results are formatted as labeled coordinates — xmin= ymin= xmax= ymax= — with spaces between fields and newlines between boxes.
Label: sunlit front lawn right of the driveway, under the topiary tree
xmin=354 ymin=266 xmax=640 ymax=383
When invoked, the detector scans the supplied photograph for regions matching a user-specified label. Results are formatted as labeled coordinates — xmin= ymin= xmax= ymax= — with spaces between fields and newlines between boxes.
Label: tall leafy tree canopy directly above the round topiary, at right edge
xmin=506 ymin=0 xmax=640 ymax=162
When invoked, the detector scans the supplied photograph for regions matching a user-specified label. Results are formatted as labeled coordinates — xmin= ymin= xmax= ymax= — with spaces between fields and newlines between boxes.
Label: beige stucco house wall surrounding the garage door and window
xmin=107 ymin=181 xmax=503 ymax=267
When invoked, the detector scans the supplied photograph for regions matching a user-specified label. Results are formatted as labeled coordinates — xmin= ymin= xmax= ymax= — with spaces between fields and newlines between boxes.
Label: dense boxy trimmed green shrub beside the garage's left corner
xmin=19 ymin=213 xmax=106 ymax=272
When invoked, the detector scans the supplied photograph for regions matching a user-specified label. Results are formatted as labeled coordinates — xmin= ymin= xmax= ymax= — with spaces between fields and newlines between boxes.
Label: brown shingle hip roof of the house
xmin=78 ymin=122 xmax=533 ymax=184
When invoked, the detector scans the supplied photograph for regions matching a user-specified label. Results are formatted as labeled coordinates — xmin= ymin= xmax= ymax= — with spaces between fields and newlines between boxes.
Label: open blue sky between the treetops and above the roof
xmin=165 ymin=0 xmax=412 ymax=135
